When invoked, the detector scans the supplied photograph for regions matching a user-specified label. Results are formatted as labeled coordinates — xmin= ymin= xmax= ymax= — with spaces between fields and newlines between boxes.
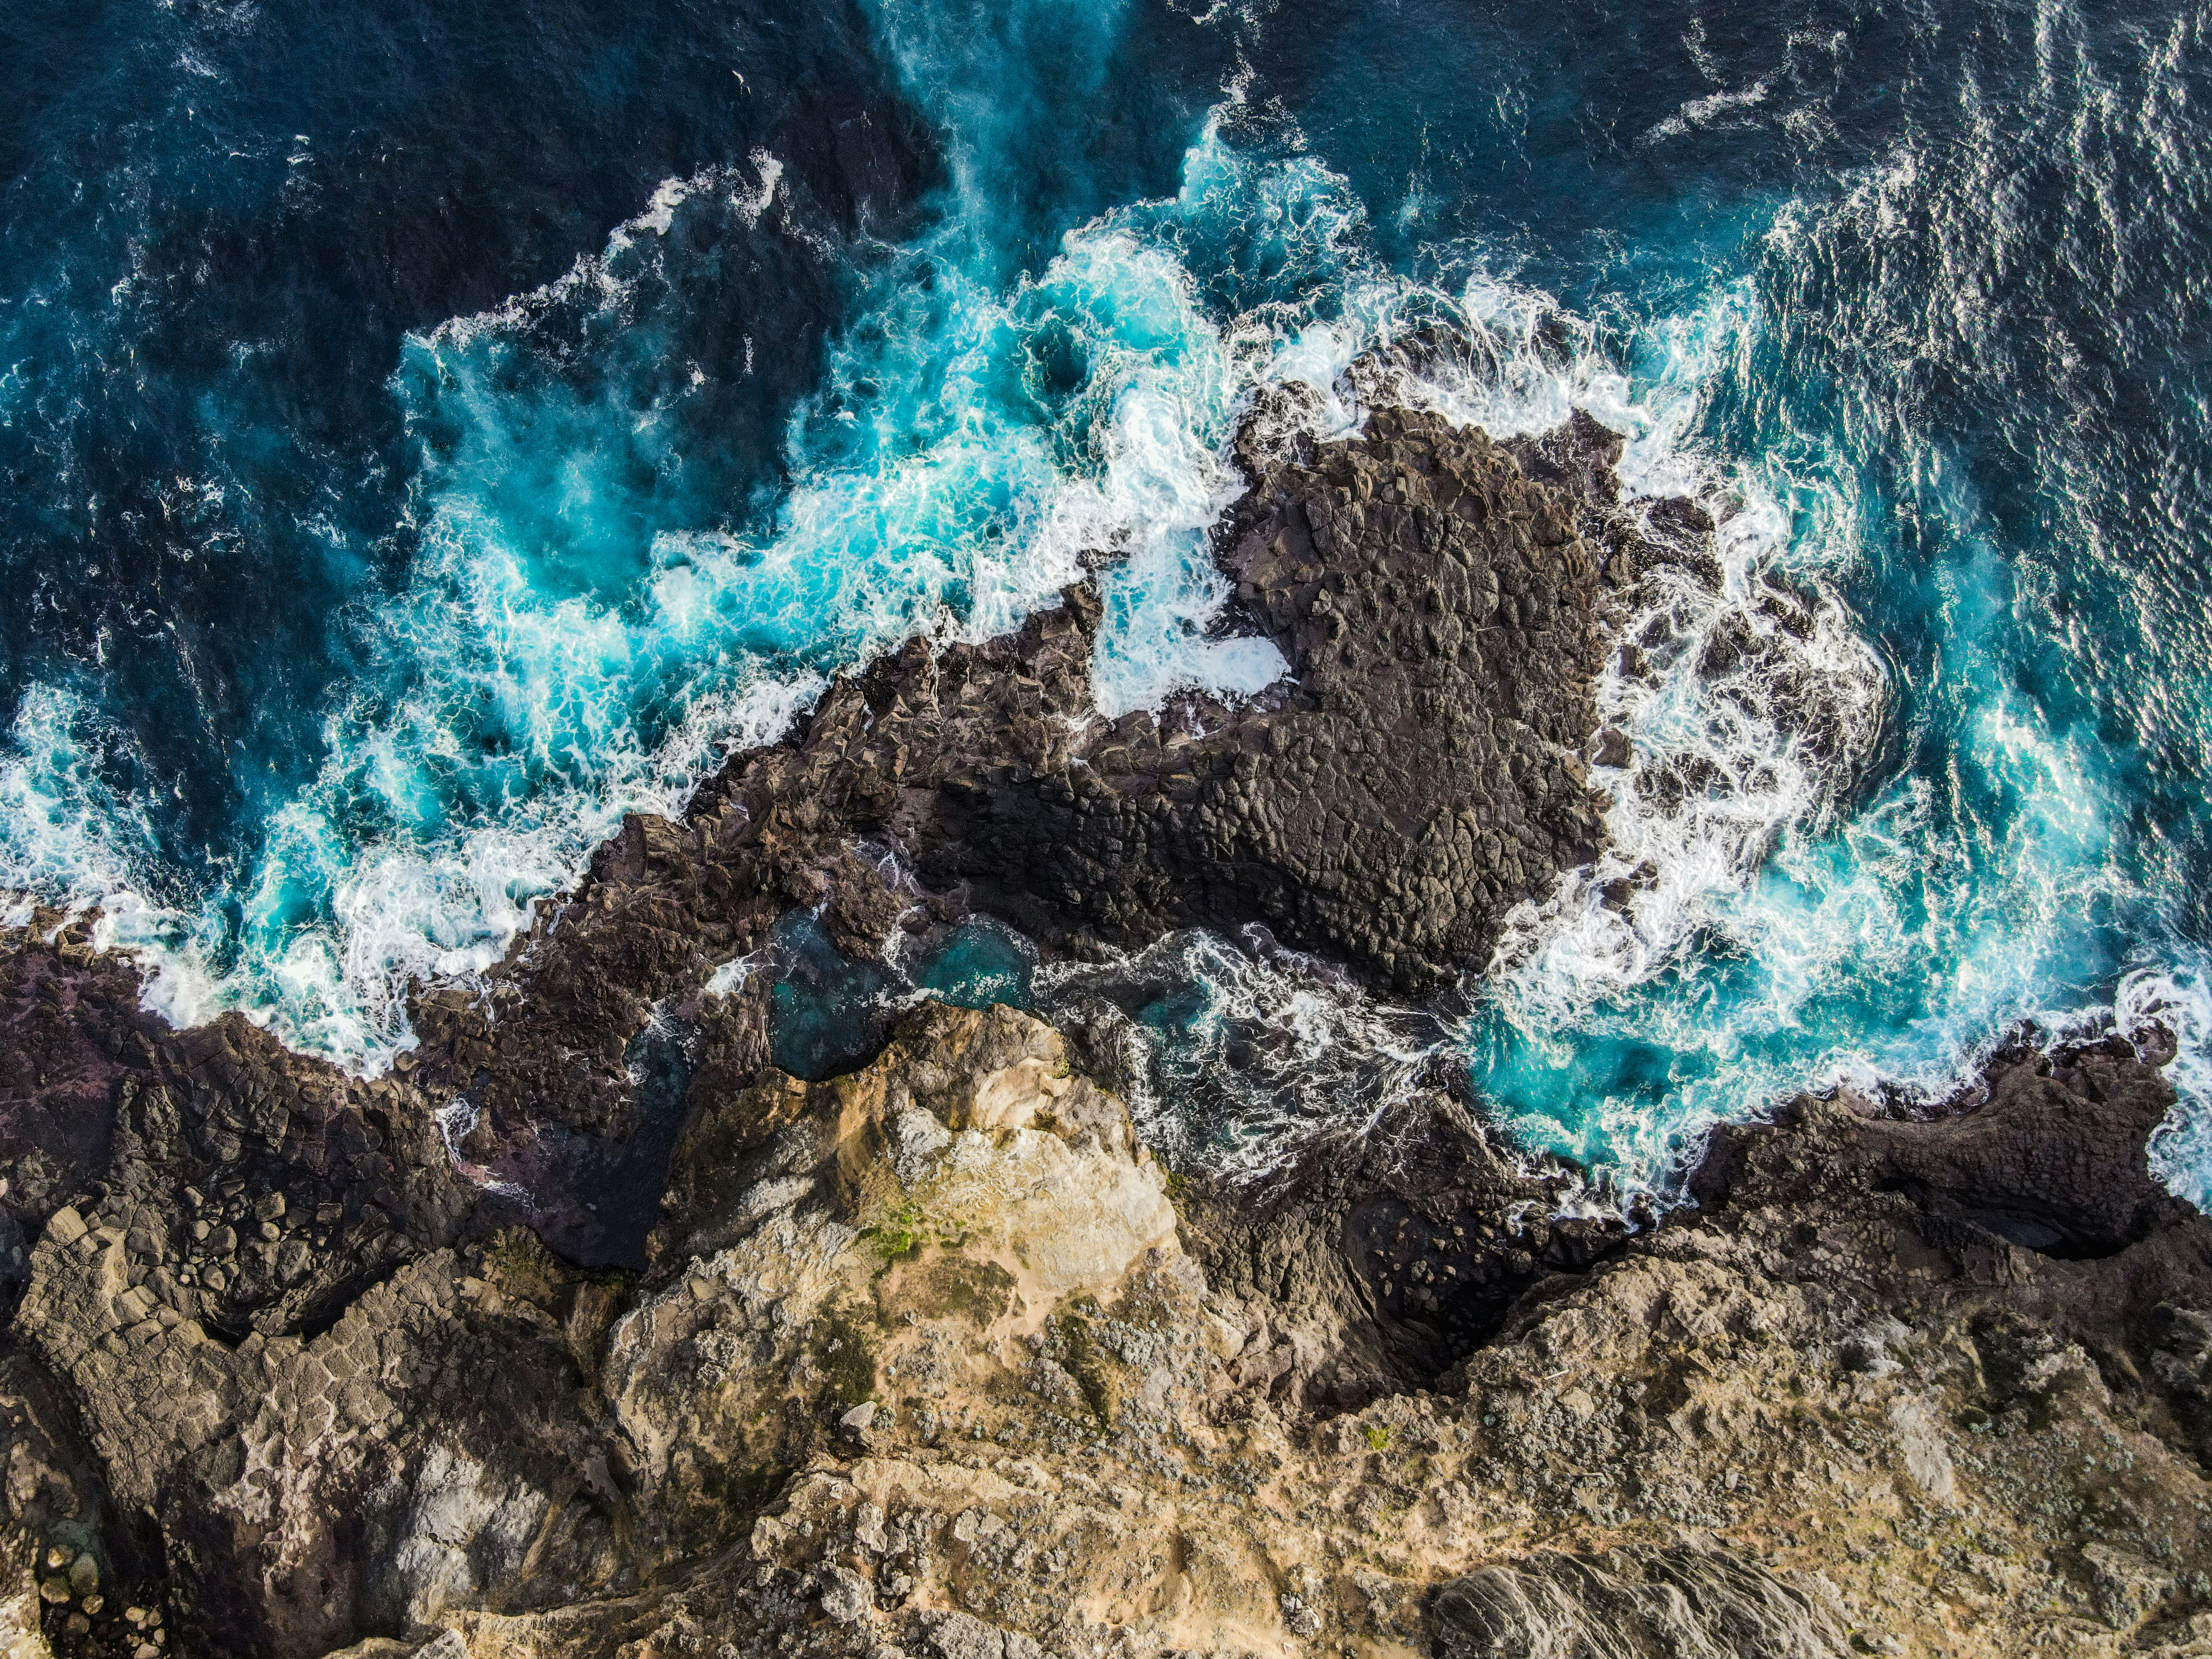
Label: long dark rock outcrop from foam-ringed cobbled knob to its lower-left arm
xmin=398 ymin=411 xmax=1604 ymax=1144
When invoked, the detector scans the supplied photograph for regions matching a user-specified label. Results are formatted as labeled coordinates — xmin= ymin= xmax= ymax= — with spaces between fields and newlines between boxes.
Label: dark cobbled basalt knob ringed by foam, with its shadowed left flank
xmin=922 ymin=411 xmax=1601 ymax=991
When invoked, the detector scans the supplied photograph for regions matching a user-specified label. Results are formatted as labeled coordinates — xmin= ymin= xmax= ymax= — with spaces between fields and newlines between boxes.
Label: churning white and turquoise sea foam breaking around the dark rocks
xmin=0 ymin=71 xmax=2212 ymax=1239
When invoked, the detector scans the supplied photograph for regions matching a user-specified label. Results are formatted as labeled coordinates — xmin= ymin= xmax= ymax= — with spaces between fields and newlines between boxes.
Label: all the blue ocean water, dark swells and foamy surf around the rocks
xmin=0 ymin=0 xmax=2212 ymax=1199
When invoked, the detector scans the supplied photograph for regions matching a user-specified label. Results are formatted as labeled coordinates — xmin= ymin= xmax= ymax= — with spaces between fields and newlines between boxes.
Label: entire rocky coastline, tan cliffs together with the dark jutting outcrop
xmin=0 ymin=402 xmax=2212 ymax=1659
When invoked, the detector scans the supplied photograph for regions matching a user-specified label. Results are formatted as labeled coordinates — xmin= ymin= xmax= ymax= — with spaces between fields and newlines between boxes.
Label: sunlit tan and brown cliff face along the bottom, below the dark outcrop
xmin=11 ymin=1004 xmax=2212 ymax=1659
